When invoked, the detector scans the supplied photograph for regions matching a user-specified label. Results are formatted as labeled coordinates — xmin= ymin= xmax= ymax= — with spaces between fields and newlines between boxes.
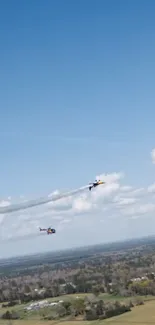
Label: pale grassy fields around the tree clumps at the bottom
xmin=0 ymin=294 xmax=155 ymax=325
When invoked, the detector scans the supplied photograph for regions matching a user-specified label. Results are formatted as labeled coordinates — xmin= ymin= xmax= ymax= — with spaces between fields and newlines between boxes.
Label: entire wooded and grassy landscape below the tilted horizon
xmin=0 ymin=237 xmax=155 ymax=325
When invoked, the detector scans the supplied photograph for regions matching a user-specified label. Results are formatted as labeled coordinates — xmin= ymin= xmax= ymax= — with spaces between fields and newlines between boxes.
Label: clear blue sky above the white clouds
xmin=0 ymin=0 xmax=155 ymax=256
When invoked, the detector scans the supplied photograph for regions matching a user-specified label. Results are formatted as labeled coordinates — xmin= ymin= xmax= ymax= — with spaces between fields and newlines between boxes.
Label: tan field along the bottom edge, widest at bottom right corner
xmin=0 ymin=301 xmax=155 ymax=325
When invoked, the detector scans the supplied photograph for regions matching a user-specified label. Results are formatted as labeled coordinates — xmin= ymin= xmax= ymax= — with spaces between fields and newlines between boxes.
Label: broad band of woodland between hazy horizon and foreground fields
xmin=0 ymin=244 xmax=155 ymax=303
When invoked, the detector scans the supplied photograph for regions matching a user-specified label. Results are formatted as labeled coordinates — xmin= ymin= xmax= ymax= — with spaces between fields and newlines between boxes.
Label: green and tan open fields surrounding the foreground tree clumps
xmin=0 ymin=294 xmax=155 ymax=325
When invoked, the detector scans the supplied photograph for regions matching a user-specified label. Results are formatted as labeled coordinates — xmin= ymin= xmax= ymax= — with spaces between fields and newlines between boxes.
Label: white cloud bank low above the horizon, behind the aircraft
xmin=0 ymin=149 xmax=155 ymax=246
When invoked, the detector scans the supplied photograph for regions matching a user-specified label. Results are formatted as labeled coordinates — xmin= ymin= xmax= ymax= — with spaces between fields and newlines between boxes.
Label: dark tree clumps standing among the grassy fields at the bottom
xmin=1 ymin=296 xmax=143 ymax=321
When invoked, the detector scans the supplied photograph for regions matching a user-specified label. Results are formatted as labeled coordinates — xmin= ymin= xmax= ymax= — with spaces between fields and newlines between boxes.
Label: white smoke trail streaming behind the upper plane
xmin=0 ymin=185 xmax=89 ymax=214
